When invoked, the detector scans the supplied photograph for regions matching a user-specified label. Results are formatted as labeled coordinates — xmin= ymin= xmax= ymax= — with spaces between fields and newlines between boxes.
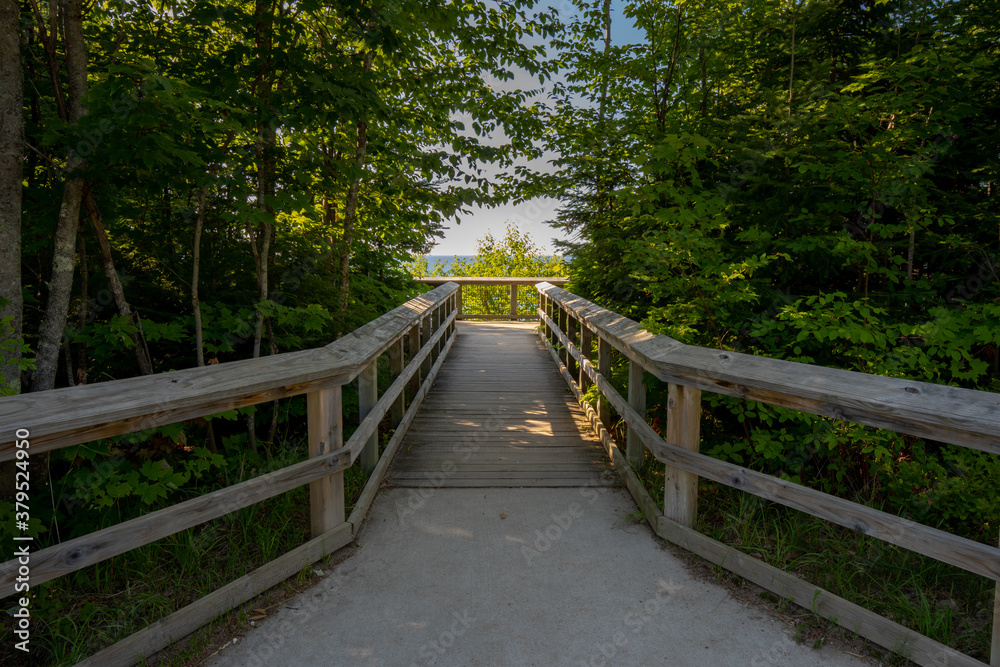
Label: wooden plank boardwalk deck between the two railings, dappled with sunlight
xmin=388 ymin=322 xmax=615 ymax=488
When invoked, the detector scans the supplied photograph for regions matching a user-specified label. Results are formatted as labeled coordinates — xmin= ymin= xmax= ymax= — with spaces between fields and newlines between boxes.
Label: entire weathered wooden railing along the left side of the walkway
xmin=0 ymin=283 xmax=458 ymax=667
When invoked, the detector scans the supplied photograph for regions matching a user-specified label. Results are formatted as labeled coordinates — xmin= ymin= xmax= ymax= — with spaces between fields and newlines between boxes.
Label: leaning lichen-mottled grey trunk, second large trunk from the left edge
xmin=31 ymin=0 xmax=87 ymax=391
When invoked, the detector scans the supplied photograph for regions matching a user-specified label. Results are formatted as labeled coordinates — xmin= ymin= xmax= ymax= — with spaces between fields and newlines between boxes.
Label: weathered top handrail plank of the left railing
xmin=0 ymin=285 xmax=458 ymax=461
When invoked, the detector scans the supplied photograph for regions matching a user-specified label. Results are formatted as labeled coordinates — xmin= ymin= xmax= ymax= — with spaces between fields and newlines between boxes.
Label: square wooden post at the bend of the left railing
xmin=306 ymin=387 xmax=344 ymax=537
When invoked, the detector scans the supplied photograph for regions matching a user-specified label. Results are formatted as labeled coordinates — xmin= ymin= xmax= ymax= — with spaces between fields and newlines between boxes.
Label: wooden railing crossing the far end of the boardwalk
xmin=413 ymin=276 xmax=569 ymax=322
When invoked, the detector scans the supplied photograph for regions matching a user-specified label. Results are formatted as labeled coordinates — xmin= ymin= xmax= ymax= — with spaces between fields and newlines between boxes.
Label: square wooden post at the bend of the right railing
xmin=663 ymin=382 xmax=701 ymax=528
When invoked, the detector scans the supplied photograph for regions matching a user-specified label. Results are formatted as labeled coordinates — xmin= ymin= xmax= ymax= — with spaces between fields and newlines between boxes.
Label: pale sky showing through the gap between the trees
xmin=430 ymin=0 xmax=641 ymax=255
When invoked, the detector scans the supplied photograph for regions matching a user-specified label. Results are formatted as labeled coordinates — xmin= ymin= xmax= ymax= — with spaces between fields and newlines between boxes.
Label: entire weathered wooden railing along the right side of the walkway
xmin=537 ymin=283 xmax=1000 ymax=667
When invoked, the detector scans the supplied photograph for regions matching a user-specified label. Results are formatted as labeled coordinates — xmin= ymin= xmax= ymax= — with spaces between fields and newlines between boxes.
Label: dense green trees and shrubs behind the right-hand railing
xmin=548 ymin=0 xmax=1000 ymax=542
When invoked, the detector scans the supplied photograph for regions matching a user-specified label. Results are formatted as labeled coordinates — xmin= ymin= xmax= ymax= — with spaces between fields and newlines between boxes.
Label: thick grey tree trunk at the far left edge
xmin=0 ymin=0 xmax=24 ymax=394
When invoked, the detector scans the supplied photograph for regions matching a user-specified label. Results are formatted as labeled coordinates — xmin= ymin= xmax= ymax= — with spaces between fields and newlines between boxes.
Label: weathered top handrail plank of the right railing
xmin=538 ymin=284 xmax=1000 ymax=453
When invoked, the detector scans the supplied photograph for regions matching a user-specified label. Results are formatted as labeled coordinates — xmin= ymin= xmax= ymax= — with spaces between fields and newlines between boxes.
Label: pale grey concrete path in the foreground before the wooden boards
xmin=207 ymin=487 xmax=868 ymax=667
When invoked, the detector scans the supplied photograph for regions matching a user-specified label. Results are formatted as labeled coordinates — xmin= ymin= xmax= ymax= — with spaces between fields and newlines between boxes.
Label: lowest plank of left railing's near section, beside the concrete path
xmin=77 ymin=523 xmax=354 ymax=667
